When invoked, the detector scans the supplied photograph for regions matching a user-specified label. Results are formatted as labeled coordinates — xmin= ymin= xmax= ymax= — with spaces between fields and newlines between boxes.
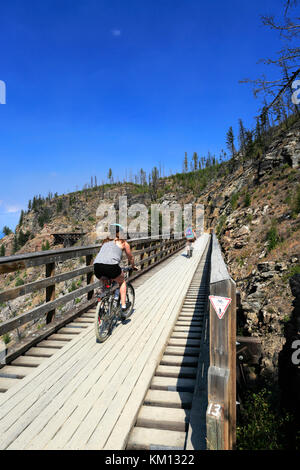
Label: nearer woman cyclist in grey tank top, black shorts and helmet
xmin=94 ymin=224 xmax=136 ymax=312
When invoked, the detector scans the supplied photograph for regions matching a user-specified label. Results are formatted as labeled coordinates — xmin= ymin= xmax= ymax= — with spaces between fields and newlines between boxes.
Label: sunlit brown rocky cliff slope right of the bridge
xmin=204 ymin=117 xmax=300 ymax=378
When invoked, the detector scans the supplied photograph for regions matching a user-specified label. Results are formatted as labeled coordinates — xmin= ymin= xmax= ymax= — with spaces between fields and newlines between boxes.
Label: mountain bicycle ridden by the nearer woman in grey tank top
xmin=95 ymin=266 xmax=135 ymax=343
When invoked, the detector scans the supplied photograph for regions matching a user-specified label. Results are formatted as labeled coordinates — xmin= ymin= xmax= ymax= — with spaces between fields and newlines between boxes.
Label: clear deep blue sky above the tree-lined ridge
xmin=0 ymin=0 xmax=284 ymax=228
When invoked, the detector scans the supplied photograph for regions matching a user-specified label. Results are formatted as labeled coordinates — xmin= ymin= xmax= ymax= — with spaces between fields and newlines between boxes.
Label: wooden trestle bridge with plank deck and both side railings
xmin=0 ymin=233 xmax=236 ymax=450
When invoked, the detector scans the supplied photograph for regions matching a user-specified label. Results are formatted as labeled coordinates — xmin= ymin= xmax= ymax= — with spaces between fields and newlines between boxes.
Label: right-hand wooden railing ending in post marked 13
xmin=206 ymin=234 xmax=236 ymax=450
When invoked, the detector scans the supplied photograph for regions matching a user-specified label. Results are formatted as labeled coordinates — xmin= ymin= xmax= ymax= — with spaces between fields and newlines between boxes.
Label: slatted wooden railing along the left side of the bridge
xmin=0 ymin=236 xmax=185 ymax=360
